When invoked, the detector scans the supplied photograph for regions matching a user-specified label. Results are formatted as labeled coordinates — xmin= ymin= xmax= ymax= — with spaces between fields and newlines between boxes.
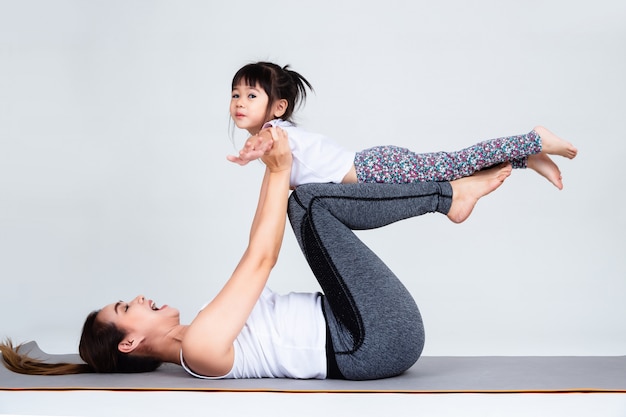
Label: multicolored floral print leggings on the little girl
xmin=354 ymin=130 xmax=541 ymax=184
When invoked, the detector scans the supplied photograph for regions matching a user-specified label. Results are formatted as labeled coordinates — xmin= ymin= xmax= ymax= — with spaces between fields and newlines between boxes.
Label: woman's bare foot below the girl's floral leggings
xmin=448 ymin=163 xmax=513 ymax=223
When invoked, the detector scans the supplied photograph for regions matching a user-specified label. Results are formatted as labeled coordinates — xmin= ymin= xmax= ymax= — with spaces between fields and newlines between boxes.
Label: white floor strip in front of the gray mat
xmin=0 ymin=391 xmax=626 ymax=417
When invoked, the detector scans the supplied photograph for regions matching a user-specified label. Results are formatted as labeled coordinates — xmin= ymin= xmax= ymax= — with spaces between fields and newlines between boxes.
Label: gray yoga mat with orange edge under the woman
xmin=0 ymin=342 xmax=626 ymax=393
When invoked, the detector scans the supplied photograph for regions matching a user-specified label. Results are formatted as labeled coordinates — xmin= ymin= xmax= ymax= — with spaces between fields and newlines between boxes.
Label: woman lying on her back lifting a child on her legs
xmin=0 ymin=128 xmax=512 ymax=380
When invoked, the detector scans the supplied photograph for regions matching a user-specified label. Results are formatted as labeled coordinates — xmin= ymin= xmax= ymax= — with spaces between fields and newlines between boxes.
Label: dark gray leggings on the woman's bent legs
xmin=289 ymin=182 xmax=452 ymax=380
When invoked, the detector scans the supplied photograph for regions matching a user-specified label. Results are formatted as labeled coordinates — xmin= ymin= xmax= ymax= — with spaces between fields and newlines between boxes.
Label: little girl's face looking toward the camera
xmin=230 ymin=84 xmax=269 ymax=135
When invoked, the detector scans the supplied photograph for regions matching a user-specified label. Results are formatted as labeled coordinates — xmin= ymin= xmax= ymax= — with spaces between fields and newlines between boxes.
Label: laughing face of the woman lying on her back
xmin=98 ymin=295 xmax=180 ymax=337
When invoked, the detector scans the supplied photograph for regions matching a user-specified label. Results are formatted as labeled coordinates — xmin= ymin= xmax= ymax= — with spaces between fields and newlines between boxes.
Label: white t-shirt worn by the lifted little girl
xmin=263 ymin=119 xmax=356 ymax=187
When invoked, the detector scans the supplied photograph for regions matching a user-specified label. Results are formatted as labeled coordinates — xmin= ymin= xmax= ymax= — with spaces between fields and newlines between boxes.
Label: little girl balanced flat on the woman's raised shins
xmin=228 ymin=62 xmax=578 ymax=189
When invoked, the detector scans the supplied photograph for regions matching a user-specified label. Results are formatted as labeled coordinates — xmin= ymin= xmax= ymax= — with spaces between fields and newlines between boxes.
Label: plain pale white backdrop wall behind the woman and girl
xmin=0 ymin=0 xmax=626 ymax=355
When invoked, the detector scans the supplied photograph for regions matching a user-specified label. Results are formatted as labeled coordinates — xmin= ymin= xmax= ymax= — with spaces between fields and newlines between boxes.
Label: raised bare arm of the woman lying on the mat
xmin=183 ymin=126 xmax=292 ymax=376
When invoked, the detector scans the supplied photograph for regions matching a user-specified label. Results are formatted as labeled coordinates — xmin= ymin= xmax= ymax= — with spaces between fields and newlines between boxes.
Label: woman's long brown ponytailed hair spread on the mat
xmin=0 ymin=311 xmax=161 ymax=375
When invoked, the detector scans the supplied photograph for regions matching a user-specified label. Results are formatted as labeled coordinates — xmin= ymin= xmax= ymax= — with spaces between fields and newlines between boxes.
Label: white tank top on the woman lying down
xmin=180 ymin=288 xmax=326 ymax=379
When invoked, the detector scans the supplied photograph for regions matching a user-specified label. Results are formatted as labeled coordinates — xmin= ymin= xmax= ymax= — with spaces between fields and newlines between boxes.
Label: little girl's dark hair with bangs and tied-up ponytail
xmin=231 ymin=61 xmax=313 ymax=122
